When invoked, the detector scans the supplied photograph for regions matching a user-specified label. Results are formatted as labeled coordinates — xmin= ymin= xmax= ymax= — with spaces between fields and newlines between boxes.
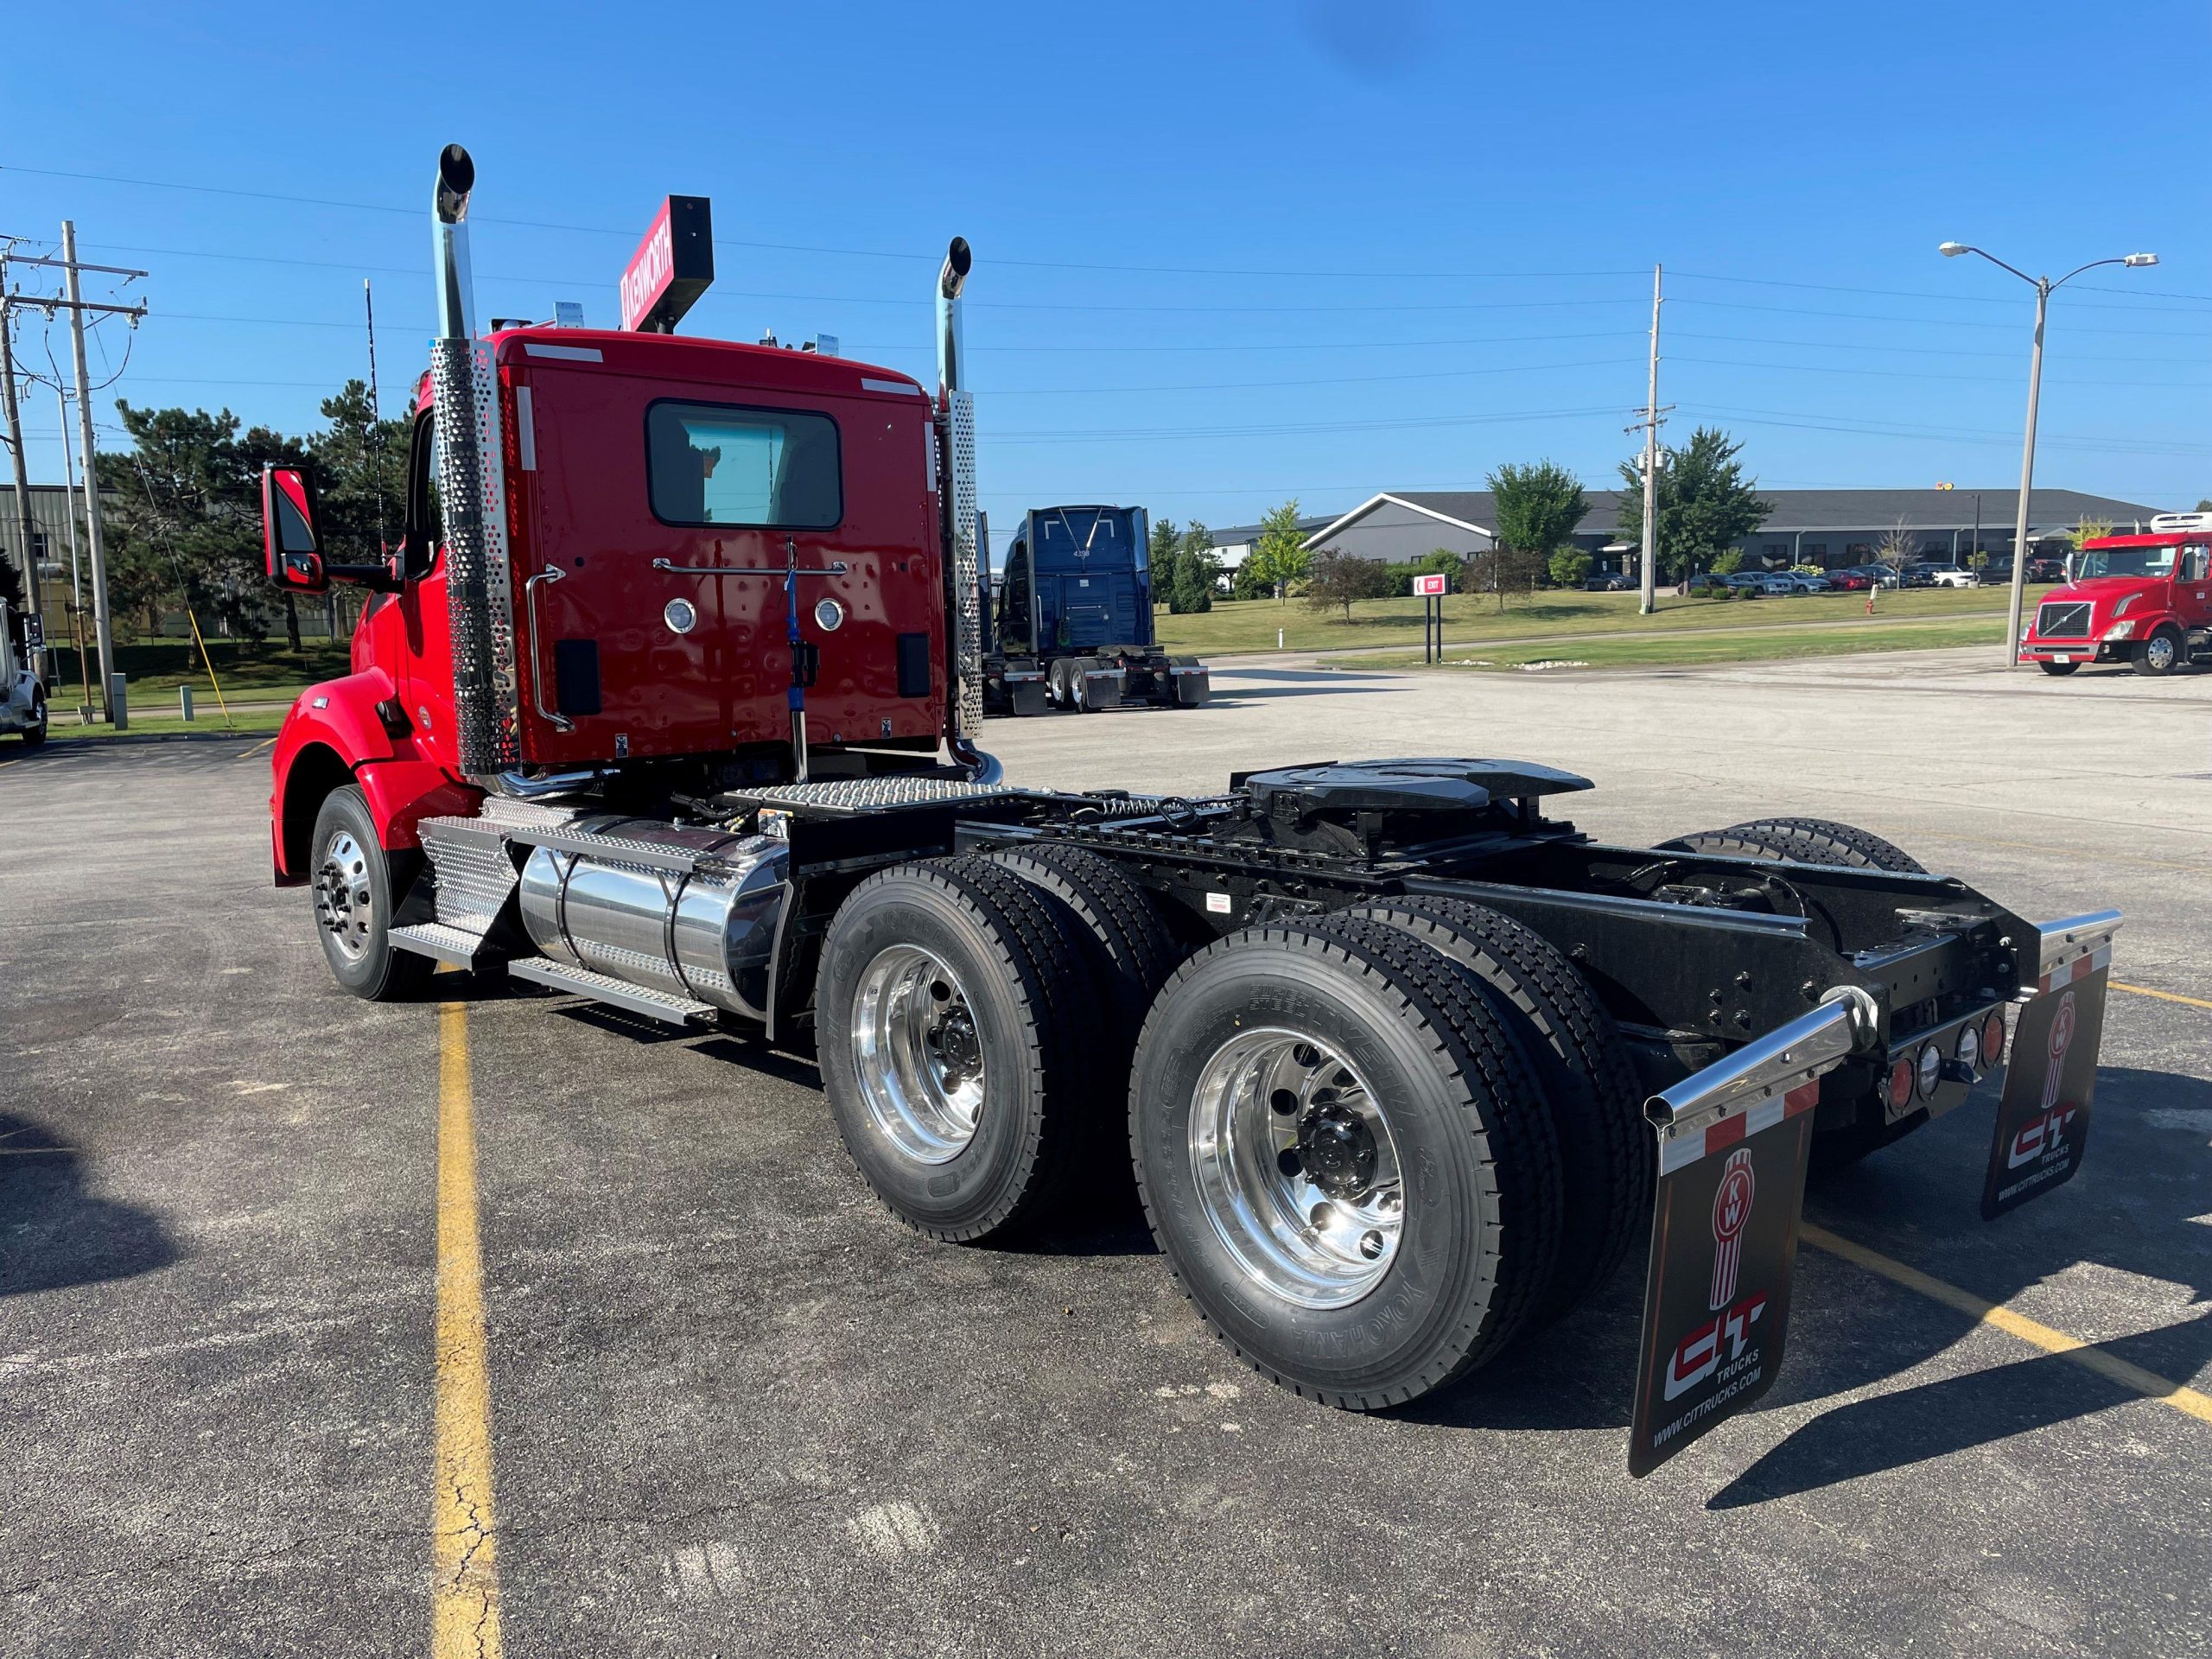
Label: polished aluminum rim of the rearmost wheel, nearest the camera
xmin=1190 ymin=1028 xmax=1405 ymax=1307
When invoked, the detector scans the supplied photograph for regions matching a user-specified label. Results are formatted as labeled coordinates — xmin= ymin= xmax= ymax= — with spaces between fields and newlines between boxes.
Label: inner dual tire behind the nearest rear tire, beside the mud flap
xmin=1344 ymin=898 xmax=1659 ymax=1320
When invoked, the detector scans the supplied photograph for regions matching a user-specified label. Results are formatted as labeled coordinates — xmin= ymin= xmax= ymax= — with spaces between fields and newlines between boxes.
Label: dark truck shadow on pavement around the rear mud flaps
xmin=1395 ymin=1066 xmax=2212 ymax=1509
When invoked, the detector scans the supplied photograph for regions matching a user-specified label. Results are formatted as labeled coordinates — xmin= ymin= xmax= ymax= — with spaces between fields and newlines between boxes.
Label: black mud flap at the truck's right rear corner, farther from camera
xmin=1982 ymin=916 xmax=2119 ymax=1221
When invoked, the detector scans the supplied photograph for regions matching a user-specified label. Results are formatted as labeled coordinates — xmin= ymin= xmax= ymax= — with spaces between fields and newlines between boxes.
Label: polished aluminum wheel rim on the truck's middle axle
xmin=852 ymin=944 xmax=984 ymax=1164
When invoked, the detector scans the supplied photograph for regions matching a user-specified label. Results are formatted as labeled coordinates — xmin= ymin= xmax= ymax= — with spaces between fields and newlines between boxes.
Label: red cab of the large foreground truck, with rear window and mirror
xmin=265 ymin=327 xmax=947 ymax=882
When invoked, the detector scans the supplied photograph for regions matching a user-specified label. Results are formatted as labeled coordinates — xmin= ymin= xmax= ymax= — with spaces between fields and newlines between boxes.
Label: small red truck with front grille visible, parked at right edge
xmin=2019 ymin=513 xmax=2212 ymax=675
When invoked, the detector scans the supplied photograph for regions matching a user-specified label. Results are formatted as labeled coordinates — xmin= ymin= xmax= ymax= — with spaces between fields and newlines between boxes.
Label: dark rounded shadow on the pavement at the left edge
xmin=0 ymin=1113 xmax=179 ymax=1296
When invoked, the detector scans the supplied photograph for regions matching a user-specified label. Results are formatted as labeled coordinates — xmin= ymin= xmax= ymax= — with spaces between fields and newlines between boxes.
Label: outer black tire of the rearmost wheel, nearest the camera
xmin=1128 ymin=916 xmax=1560 ymax=1411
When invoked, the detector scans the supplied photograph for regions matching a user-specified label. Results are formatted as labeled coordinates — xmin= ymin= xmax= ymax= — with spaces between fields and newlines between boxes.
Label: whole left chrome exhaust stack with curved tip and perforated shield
xmin=431 ymin=143 xmax=522 ymax=787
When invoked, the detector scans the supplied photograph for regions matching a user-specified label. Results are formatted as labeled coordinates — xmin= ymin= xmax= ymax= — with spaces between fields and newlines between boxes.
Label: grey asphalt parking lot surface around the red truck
xmin=0 ymin=652 xmax=2212 ymax=1656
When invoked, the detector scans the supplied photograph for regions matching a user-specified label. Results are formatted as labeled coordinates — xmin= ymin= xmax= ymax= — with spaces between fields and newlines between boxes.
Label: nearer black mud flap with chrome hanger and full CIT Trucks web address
xmin=1628 ymin=1000 xmax=1873 ymax=1480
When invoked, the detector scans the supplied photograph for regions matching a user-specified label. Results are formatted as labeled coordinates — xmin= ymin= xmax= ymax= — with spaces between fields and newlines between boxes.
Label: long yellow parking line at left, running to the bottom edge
xmin=429 ymin=1002 xmax=500 ymax=1659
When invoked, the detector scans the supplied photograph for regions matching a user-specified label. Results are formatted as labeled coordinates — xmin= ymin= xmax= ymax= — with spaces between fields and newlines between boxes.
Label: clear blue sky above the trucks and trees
xmin=0 ymin=0 xmax=2212 ymax=559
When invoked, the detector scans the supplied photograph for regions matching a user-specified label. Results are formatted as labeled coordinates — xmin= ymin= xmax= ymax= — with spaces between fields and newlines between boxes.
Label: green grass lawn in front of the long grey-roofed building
xmin=1157 ymin=586 xmax=2046 ymax=657
